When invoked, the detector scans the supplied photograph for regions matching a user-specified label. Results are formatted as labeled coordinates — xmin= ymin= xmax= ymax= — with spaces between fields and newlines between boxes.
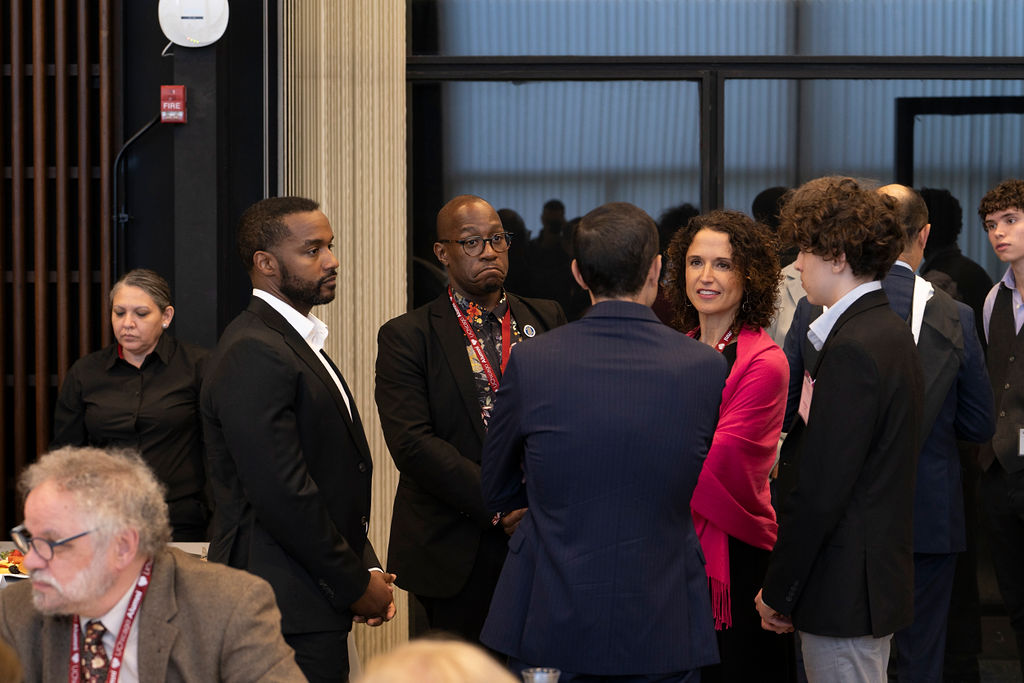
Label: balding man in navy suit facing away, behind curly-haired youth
xmin=879 ymin=184 xmax=995 ymax=681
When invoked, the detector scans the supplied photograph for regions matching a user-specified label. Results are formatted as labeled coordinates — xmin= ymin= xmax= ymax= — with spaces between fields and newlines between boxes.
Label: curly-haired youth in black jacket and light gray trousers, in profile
xmin=756 ymin=177 xmax=924 ymax=683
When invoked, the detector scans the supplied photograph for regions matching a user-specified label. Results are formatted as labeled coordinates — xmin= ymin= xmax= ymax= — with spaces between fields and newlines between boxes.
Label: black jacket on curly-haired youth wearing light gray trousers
xmin=763 ymin=292 xmax=924 ymax=637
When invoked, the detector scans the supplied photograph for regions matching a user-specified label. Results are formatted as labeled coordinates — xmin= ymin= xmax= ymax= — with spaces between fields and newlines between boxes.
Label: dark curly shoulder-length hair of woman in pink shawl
xmin=663 ymin=209 xmax=782 ymax=333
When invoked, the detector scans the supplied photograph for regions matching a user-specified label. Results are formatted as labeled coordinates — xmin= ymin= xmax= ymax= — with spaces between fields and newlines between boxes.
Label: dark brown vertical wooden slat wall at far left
xmin=0 ymin=0 xmax=112 ymax=528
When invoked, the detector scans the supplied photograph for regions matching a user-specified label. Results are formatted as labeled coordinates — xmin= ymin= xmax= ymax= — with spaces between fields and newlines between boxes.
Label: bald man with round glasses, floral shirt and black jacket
xmin=376 ymin=195 xmax=565 ymax=642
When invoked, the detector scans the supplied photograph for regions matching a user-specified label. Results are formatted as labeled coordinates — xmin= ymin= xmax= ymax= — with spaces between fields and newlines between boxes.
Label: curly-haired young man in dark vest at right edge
xmin=978 ymin=180 xmax=1024 ymax=671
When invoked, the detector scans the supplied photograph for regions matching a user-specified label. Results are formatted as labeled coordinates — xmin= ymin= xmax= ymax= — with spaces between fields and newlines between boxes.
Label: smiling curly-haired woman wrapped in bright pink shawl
xmin=666 ymin=211 xmax=792 ymax=683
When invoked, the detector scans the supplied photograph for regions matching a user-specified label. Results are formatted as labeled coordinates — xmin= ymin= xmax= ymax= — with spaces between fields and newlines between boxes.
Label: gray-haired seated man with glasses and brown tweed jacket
xmin=0 ymin=447 xmax=305 ymax=683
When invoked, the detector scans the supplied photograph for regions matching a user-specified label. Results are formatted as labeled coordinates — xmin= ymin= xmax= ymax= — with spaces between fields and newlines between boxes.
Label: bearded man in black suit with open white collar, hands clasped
xmin=200 ymin=197 xmax=394 ymax=682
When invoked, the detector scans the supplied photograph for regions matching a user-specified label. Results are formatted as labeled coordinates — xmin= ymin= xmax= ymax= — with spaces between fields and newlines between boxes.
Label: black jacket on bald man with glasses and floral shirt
xmin=375 ymin=292 xmax=565 ymax=598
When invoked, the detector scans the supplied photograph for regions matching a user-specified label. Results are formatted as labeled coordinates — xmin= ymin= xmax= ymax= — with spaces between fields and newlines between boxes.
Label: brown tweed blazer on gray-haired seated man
xmin=0 ymin=549 xmax=306 ymax=683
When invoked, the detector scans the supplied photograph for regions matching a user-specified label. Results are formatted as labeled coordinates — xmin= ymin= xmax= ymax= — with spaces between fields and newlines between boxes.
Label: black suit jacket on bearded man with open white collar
xmin=200 ymin=297 xmax=378 ymax=634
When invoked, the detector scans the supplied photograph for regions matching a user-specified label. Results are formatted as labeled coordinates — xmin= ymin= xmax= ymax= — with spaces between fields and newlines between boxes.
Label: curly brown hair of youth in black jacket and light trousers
xmin=779 ymin=176 xmax=903 ymax=280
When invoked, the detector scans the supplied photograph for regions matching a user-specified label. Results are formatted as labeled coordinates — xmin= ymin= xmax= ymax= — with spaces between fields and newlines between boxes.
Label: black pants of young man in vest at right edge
xmin=981 ymin=461 xmax=1024 ymax=673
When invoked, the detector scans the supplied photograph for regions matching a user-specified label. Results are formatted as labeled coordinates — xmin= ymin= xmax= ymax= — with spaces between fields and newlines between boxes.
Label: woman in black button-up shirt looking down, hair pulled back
xmin=51 ymin=268 xmax=210 ymax=541
